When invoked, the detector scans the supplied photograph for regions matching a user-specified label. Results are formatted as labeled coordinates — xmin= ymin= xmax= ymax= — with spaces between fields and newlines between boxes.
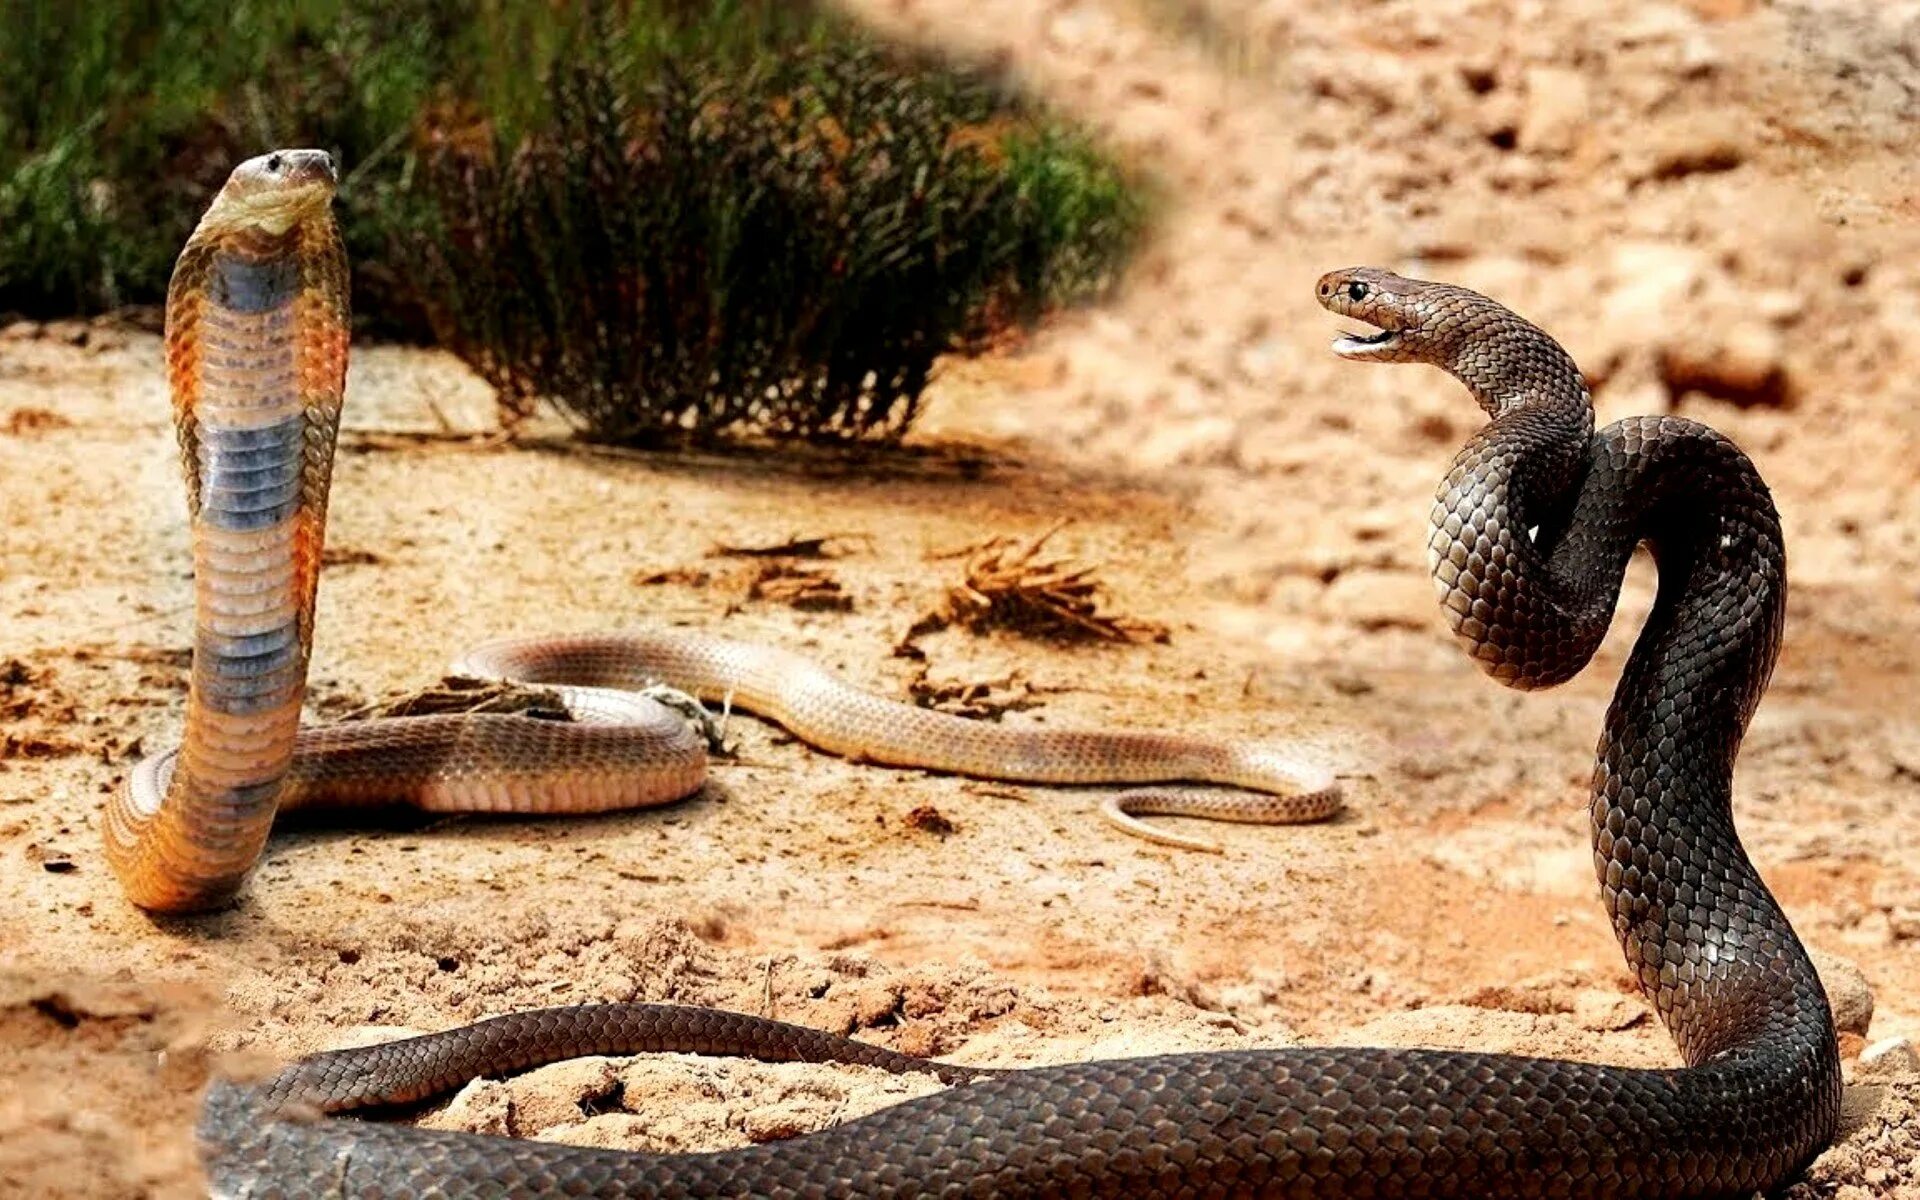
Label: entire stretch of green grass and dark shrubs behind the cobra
xmin=0 ymin=0 xmax=1148 ymax=442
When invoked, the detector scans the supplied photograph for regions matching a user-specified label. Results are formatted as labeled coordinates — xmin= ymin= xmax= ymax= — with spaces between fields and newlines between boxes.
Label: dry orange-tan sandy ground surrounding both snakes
xmin=0 ymin=0 xmax=1920 ymax=1200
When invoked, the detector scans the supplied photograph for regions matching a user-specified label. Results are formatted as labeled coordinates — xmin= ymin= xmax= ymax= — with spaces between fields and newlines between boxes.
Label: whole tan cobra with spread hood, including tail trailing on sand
xmin=104 ymin=150 xmax=1340 ymax=912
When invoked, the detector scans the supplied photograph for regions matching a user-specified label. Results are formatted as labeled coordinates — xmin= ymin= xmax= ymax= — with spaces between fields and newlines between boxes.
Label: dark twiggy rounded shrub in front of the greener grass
xmin=410 ymin=48 xmax=1082 ymax=440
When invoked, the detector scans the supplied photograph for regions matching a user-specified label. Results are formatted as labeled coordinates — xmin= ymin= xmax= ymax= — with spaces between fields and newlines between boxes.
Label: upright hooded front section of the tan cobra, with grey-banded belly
xmin=104 ymin=150 xmax=348 ymax=910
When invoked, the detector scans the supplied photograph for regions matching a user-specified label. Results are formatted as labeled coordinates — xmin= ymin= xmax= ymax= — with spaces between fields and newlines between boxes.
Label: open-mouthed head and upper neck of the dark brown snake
xmin=1315 ymin=267 xmax=1586 ymax=417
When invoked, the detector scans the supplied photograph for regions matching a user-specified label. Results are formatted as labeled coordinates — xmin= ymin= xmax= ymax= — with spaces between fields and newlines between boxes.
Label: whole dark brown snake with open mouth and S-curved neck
xmin=200 ymin=255 xmax=1839 ymax=1200
